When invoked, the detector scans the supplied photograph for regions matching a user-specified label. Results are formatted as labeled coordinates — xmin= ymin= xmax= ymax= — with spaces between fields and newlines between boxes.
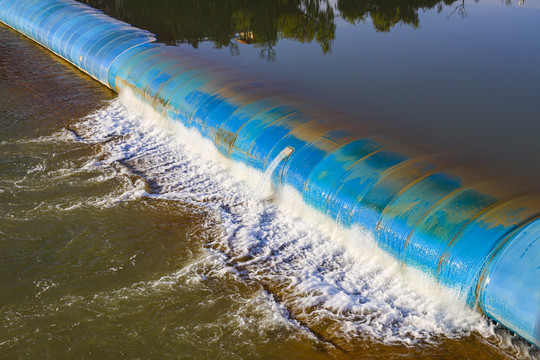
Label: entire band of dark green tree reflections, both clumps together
xmin=81 ymin=0 xmax=464 ymax=57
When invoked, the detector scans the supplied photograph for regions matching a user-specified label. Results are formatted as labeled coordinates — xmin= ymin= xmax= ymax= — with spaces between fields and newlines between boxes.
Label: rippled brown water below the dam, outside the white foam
xmin=0 ymin=21 xmax=536 ymax=359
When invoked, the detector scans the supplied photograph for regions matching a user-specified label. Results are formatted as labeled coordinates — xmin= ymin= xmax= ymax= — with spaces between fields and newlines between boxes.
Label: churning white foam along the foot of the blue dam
xmin=53 ymin=93 xmax=530 ymax=357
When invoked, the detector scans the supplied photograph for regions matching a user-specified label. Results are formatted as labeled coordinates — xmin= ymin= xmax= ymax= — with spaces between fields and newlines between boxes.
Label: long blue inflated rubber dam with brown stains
xmin=0 ymin=0 xmax=540 ymax=346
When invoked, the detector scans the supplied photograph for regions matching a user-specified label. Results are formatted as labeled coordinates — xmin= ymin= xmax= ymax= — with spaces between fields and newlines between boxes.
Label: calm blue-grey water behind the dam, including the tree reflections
xmin=82 ymin=0 xmax=540 ymax=188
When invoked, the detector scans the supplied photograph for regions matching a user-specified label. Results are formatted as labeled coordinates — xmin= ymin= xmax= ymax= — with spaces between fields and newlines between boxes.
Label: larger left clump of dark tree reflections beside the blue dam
xmin=82 ymin=0 xmax=336 ymax=60
